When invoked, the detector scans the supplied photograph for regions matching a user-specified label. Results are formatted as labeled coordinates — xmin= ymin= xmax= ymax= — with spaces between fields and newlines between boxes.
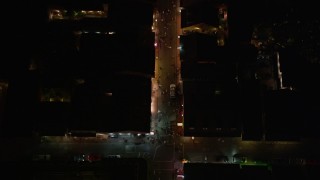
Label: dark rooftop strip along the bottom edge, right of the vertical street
xmin=184 ymin=162 xmax=319 ymax=180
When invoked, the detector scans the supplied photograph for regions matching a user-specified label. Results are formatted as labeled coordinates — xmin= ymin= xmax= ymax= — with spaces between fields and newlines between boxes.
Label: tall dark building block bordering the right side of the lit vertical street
xmin=180 ymin=1 xmax=241 ymax=137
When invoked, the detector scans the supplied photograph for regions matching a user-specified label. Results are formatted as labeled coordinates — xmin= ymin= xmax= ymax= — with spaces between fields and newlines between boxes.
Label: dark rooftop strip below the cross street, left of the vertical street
xmin=4 ymin=158 xmax=148 ymax=180
